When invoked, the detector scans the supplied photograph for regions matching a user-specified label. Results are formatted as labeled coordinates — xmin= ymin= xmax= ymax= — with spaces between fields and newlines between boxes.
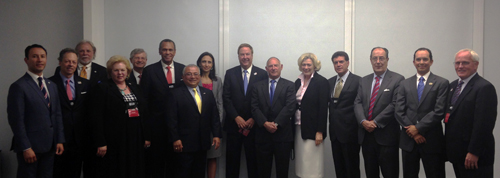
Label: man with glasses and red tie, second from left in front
xmin=49 ymin=48 xmax=91 ymax=178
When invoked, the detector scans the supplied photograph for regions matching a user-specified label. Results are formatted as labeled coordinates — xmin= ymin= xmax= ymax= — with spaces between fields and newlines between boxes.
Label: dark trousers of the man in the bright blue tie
xmin=401 ymin=143 xmax=446 ymax=178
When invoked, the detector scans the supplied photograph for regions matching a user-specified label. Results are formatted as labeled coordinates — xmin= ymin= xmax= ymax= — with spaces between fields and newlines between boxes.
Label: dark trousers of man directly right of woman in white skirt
xmin=331 ymin=139 xmax=360 ymax=178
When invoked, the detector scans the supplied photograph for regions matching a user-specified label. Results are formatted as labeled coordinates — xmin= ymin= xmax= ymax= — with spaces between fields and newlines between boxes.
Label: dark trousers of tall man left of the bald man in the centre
xmin=226 ymin=130 xmax=258 ymax=178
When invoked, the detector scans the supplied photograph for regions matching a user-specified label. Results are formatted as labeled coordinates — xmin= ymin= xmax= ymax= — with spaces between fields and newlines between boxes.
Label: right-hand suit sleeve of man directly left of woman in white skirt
xmin=274 ymin=83 xmax=297 ymax=126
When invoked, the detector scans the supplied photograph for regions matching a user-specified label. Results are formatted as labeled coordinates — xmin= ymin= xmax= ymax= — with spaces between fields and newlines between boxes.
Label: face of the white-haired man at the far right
xmin=455 ymin=51 xmax=479 ymax=80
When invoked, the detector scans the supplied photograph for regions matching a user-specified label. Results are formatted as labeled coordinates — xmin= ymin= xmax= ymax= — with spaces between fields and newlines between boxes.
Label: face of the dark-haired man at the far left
xmin=24 ymin=47 xmax=47 ymax=76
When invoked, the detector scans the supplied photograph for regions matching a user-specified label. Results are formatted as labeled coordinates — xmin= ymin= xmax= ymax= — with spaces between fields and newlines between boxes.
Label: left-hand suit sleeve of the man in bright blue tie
xmin=394 ymin=80 xmax=413 ymax=127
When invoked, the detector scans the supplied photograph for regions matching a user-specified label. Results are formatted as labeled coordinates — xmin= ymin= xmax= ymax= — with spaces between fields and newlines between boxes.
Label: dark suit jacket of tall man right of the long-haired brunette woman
xmin=223 ymin=65 xmax=267 ymax=133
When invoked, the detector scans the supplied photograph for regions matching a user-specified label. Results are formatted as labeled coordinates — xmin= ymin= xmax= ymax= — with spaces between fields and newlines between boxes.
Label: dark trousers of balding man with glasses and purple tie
xmin=362 ymin=131 xmax=399 ymax=178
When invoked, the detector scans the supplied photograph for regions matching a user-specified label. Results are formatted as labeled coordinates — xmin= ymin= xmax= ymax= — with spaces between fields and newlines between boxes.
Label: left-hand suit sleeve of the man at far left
xmin=7 ymin=83 xmax=31 ymax=152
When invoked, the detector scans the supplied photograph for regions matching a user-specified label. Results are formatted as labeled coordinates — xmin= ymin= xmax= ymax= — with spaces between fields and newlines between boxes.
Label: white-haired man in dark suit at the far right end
xmin=445 ymin=49 xmax=498 ymax=178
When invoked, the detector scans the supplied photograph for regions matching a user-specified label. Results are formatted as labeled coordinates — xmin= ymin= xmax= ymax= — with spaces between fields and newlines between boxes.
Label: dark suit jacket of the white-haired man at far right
xmin=445 ymin=74 xmax=498 ymax=167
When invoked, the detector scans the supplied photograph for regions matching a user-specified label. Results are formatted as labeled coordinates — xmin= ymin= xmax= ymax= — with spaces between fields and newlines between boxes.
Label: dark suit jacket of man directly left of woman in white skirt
xmin=252 ymin=78 xmax=297 ymax=143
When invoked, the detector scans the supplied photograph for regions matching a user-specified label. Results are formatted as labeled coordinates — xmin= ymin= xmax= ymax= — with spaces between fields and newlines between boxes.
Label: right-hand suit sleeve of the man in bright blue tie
xmin=415 ymin=80 xmax=448 ymax=133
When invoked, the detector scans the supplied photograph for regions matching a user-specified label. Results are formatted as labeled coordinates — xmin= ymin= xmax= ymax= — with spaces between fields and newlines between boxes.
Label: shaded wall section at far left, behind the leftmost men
xmin=0 ymin=0 xmax=83 ymax=178
